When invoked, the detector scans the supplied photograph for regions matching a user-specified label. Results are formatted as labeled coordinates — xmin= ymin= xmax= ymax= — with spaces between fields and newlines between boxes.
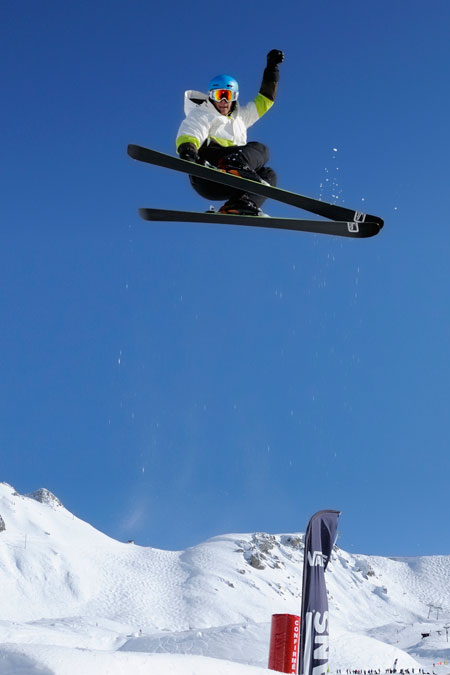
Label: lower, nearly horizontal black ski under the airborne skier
xmin=139 ymin=209 xmax=380 ymax=238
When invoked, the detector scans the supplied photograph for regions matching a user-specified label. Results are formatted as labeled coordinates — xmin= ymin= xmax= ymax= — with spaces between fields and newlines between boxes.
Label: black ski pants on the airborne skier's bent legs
xmin=189 ymin=141 xmax=277 ymax=208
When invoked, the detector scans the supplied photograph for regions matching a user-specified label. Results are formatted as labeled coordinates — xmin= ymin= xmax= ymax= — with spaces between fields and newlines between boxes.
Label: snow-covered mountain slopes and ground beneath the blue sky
xmin=0 ymin=483 xmax=450 ymax=675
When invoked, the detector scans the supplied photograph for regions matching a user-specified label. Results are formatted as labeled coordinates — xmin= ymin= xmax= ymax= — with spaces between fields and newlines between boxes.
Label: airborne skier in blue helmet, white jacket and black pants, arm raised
xmin=176 ymin=49 xmax=284 ymax=216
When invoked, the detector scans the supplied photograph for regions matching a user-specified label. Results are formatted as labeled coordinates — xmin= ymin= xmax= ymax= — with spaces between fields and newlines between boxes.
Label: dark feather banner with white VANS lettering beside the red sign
xmin=299 ymin=511 xmax=340 ymax=675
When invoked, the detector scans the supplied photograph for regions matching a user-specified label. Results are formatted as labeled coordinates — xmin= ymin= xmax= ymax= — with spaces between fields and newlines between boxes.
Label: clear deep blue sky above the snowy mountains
xmin=0 ymin=0 xmax=450 ymax=555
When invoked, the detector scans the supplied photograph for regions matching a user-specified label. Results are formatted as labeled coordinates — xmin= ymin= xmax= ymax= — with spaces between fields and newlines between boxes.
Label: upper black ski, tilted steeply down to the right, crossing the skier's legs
xmin=128 ymin=144 xmax=384 ymax=230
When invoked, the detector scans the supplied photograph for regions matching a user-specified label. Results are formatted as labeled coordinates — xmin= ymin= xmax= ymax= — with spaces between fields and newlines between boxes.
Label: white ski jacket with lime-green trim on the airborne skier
xmin=176 ymin=90 xmax=273 ymax=150
